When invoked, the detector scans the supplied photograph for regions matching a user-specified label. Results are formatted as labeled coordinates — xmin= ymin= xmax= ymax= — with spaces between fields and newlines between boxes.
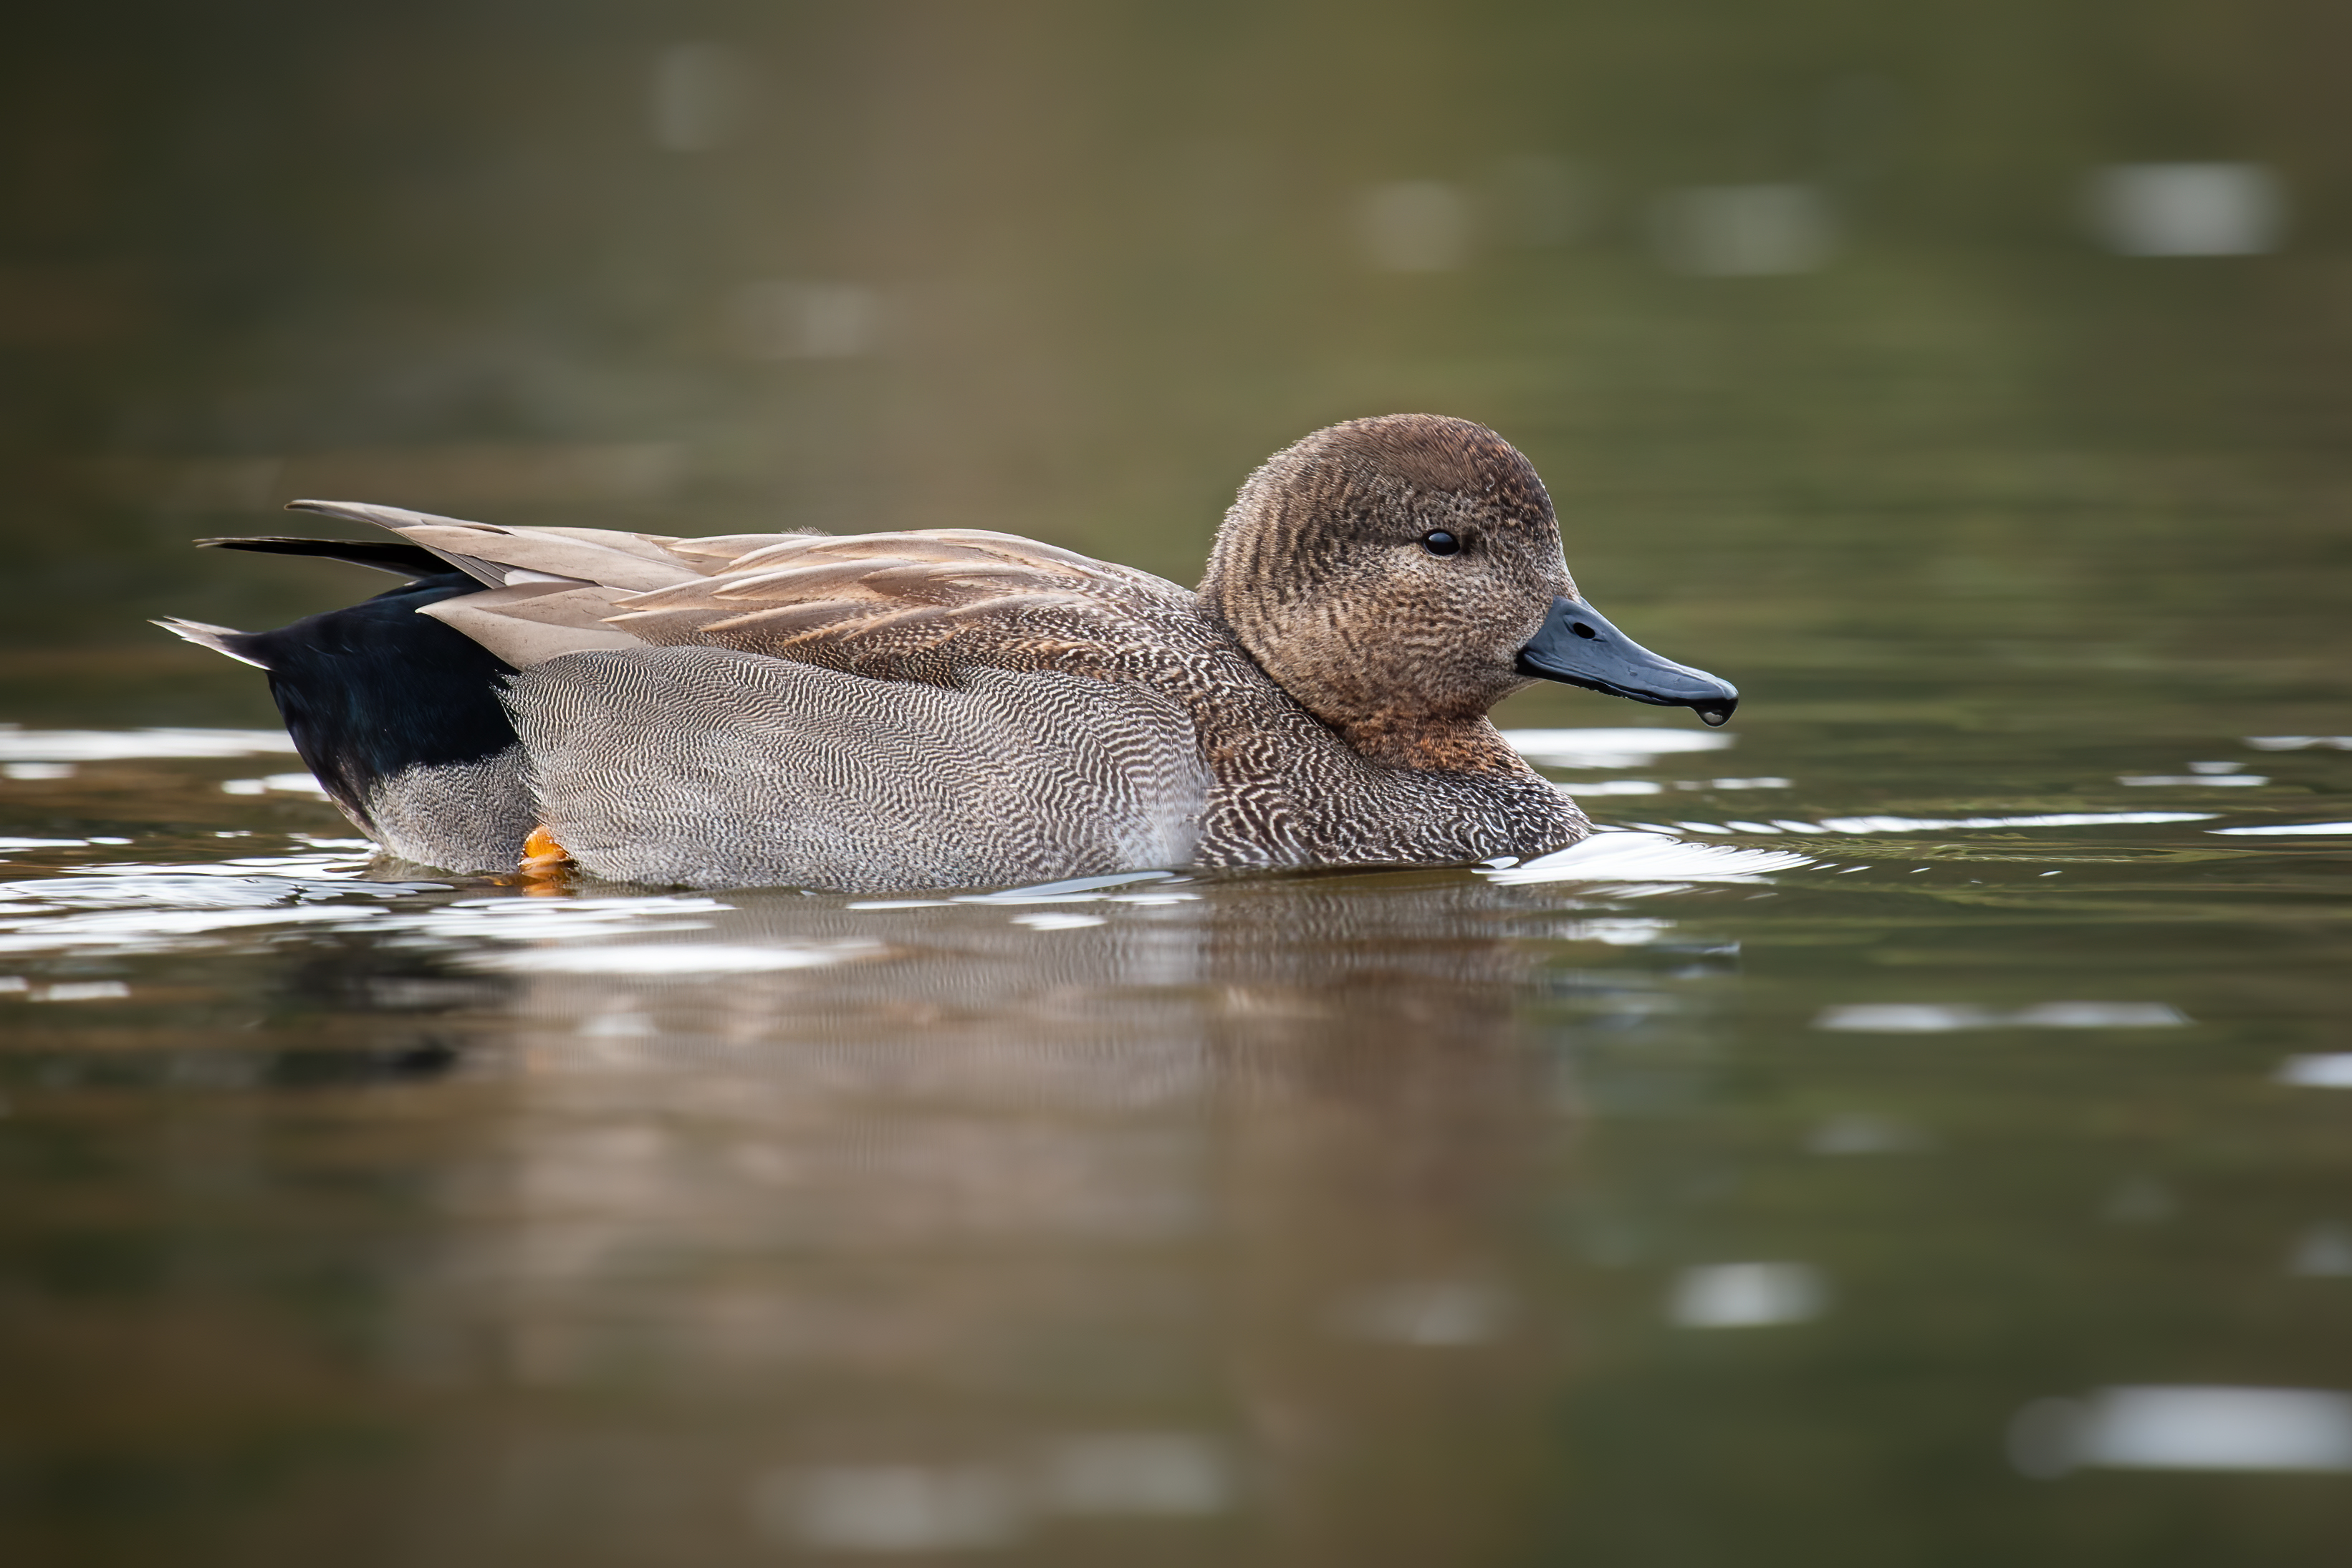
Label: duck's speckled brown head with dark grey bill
xmin=1199 ymin=414 xmax=1738 ymax=766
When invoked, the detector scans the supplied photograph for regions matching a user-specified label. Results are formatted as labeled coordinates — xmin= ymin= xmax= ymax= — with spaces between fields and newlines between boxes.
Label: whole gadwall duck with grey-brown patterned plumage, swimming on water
xmin=158 ymin=414 xmax=1738 ymax=891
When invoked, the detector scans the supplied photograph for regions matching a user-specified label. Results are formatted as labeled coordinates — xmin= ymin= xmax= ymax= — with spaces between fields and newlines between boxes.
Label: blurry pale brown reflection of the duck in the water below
xmin=413 ymin=872 xmax=1656 ymax=1561
